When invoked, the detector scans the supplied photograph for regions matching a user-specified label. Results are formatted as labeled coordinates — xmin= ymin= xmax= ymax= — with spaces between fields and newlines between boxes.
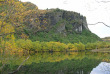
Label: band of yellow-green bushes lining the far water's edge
xmin=0 ymin=39 xmax=110 ymax=54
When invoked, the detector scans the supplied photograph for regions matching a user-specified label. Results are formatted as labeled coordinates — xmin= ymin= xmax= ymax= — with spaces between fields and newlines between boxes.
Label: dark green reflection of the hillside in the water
xmin=15 ymin=58 xmax=100 ymax=74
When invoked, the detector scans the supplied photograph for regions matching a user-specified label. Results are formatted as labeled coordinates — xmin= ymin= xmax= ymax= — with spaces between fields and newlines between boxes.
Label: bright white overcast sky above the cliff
xmin=21 ymin=0 xmax=110 ymax=38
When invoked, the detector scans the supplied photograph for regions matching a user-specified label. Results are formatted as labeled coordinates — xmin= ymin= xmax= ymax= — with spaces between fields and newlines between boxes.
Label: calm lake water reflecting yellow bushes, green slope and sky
xmin=0 ymin=52 xmax=110 ymax=74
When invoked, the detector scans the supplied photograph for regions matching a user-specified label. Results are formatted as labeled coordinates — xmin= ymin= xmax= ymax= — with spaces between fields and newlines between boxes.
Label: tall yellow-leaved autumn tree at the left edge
xmin=0 ymin=0 xmax=24 ymax=52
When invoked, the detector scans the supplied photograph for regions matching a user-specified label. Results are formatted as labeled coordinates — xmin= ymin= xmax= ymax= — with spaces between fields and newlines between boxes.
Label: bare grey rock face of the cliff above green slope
xmin=24 ymin=9 xmax=89 ymax=33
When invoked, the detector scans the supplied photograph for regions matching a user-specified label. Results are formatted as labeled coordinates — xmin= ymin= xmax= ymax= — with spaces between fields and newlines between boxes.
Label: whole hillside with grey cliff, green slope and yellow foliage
xmin=0 ymin=0 xmax=101 ymax=43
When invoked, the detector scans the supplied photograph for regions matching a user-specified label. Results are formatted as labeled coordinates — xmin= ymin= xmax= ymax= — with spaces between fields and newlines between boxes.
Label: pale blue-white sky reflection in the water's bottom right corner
xmin=90 ymin=62 xmax=110 ymax=74
